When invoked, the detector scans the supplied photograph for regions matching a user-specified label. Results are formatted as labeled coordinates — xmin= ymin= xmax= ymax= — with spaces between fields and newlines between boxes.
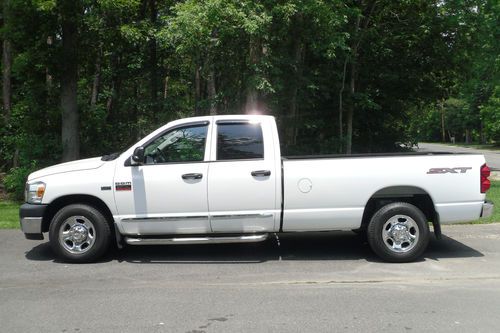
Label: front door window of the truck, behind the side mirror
xmin=144 ymin=125 xmax=208 ymax=164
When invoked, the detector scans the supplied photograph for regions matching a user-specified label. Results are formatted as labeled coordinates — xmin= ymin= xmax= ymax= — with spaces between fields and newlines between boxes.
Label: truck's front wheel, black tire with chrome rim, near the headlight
xmin=49 ymin=204 xmax=111 ymax=263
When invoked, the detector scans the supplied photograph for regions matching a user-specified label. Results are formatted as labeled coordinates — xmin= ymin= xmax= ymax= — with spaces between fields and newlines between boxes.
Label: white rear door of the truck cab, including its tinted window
xmin=208 ymin=119 xmax=280 ymax=233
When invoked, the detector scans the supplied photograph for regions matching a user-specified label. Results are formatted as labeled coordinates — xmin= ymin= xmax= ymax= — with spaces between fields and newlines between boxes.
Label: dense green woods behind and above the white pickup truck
xmin=0 ymin=0 xmax=500 ymax=196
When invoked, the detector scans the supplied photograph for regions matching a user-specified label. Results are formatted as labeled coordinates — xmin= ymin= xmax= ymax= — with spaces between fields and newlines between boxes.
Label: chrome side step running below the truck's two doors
xmin=124 ymin=234 xmax=268 ymax=245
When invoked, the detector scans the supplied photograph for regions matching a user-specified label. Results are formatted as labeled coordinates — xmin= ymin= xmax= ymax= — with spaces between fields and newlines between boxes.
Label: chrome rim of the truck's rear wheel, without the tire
xmin=382 ymin=215 xmax=420 ymax=253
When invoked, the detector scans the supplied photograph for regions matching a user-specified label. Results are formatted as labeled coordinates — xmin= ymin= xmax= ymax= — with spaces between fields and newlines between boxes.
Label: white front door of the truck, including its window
xmin=115 ymin=122 xmax=210 ymax=235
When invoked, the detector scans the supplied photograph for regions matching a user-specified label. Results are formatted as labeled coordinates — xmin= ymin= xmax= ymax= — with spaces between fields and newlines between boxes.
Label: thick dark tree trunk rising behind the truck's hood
xmin=61 ymin=1 xmax=80 ymax=161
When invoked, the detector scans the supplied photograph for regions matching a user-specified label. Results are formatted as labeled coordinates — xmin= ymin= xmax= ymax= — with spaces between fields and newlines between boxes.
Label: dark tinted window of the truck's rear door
xmin=217 ymin=123 xmax=264 ymax=160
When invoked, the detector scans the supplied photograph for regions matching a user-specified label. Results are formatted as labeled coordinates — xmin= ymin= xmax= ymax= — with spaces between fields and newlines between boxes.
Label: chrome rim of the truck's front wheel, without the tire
xmin=59 ymin=216 xmax=96 ymax=254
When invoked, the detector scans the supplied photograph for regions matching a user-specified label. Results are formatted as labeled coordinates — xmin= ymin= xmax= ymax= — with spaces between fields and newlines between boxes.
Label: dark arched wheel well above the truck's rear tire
xmin=361 ymin=186 xmax=440 ymax=232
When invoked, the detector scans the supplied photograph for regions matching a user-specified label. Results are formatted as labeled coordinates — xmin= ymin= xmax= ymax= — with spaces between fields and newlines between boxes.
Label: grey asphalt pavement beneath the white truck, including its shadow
xmin=0 ymin=224 xmax=500 ymax=333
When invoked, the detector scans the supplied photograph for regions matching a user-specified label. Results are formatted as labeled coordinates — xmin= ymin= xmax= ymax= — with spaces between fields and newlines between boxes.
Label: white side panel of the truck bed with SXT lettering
xmin=283 ymin=155 xmax=485 ymax=231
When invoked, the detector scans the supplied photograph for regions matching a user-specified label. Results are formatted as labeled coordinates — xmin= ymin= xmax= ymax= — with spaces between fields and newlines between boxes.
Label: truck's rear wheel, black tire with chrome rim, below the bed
xmin=367 ymin=202 xmax=430 ymax=262
